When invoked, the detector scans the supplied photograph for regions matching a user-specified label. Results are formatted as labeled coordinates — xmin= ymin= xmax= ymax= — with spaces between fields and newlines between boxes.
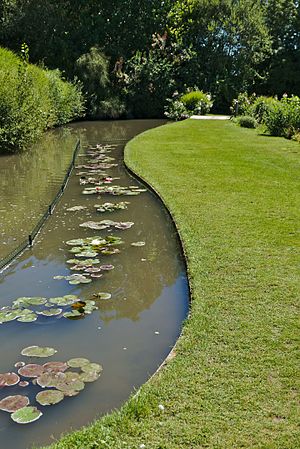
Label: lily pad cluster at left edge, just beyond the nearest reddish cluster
xmin=0 ymin=293 xmax=102 ymax=324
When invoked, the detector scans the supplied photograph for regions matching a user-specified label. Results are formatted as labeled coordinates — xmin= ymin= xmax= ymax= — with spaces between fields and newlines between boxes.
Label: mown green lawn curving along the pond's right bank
xmin=44 ymin=120 xmax=300 ymax=449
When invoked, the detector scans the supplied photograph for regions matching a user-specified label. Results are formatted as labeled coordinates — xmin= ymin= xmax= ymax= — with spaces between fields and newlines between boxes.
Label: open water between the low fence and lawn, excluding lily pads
xmin=0 ymin=121 xmax=188 ymax=449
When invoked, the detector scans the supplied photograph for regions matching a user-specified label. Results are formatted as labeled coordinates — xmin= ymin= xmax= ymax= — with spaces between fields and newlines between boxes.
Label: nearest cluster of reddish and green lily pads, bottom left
xmin=0 ymin=346 xmax=102 ymax=424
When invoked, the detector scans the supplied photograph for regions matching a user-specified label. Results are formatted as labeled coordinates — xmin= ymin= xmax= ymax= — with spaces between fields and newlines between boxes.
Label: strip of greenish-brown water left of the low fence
xmin=0 ymin=128 xmax=76 ymax=256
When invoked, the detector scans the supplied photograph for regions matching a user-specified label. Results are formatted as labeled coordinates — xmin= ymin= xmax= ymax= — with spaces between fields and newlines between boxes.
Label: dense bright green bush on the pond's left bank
xmin=0 ymin=46 xmax=84 ymax=153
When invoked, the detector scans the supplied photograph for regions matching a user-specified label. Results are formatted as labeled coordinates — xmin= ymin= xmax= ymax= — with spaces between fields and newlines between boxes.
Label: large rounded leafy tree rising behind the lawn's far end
xmin=169 ymin=0 xmax=271 ymax=109
